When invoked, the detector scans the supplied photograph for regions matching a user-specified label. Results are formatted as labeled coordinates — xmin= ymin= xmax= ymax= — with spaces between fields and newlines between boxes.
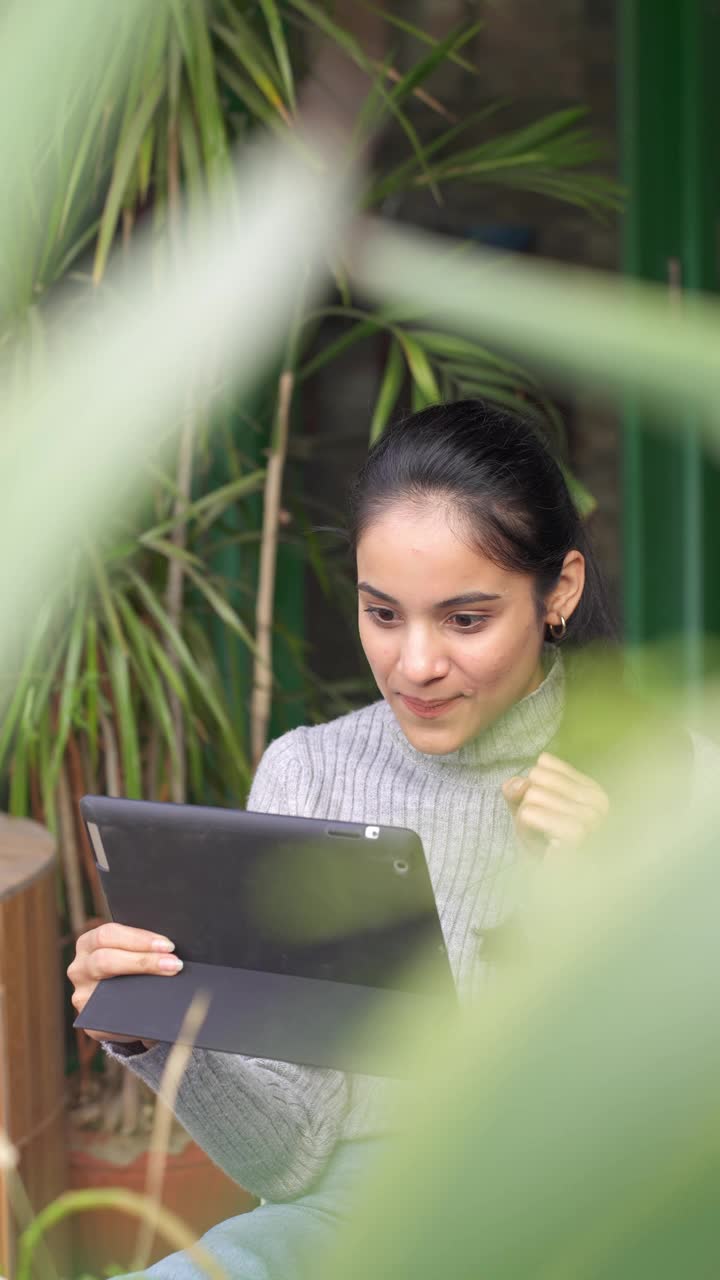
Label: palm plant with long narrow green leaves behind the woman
xmin=0 ymin=0 xmax=619 ymax=1126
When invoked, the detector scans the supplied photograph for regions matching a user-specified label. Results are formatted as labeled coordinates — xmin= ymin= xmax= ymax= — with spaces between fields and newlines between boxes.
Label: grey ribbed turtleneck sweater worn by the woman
xmin=110 ymin=657 xmax=564 ymax=1201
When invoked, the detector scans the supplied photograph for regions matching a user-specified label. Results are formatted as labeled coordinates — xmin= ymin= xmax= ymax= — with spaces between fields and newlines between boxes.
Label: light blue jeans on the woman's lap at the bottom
xmin=123 ymin=1139 xmax=383 ymax=1280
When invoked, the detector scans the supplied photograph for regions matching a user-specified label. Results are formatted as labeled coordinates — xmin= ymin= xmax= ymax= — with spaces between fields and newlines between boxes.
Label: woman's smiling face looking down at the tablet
xmin=357 ymin=500 xmax=544 ymax=755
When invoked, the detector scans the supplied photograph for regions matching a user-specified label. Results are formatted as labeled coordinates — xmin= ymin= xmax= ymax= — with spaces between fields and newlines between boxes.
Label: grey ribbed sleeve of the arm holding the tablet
xmin=105 ymin=732 xmax=350 ymax=1201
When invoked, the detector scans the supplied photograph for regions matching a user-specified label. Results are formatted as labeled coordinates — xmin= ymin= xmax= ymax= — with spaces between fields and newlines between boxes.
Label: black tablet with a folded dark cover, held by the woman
xmin=74 ymin=796 xmax=456 ymax=1075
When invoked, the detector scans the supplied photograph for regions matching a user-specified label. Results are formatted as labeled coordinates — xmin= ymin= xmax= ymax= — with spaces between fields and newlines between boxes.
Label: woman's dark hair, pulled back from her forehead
xmin=350 ymin=399 xmax=615 ymax=645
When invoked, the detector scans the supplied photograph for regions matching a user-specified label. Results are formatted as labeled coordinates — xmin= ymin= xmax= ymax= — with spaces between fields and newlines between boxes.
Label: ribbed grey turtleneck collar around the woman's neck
xmin=384 ymin=645 xmax=565 ymax=768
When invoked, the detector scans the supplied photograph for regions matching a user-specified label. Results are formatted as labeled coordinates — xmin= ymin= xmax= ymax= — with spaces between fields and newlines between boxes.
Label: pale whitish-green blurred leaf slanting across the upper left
xmin=0 ymin=129 xmax=353 ymax=686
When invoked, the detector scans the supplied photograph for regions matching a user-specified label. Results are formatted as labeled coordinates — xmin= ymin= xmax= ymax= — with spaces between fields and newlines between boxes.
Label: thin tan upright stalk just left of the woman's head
xmin=250 ymin=369 xmax=289 ymax=767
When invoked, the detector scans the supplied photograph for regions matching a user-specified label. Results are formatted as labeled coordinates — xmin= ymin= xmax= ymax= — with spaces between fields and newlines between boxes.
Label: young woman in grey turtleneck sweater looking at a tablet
xmin=69 ymin=401 xmax=684 ymax=1277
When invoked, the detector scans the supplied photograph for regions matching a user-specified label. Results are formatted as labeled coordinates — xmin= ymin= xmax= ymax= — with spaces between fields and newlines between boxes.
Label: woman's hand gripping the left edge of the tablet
xmin=68 ymin=923 xmax=182 ymax=1048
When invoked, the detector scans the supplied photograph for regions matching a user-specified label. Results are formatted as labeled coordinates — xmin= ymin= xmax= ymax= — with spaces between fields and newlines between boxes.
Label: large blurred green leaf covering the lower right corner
xmin=315 ymin=700 xmax=720 ymax=1280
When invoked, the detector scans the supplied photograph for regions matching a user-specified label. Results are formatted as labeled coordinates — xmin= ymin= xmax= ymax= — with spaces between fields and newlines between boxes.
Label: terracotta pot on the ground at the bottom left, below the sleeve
xmin=68 ymin=1128 xmax=258 ymax=1275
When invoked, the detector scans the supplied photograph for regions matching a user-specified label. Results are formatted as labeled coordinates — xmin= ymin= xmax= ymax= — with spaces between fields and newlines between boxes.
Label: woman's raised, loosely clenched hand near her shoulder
xmin=502 ymin=751 xmax=610 ymax=852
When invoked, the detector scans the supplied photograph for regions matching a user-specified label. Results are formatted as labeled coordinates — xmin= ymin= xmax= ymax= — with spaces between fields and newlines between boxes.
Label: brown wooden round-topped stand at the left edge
xmin=0 ymin=814 xmax=65 ymax=1276
